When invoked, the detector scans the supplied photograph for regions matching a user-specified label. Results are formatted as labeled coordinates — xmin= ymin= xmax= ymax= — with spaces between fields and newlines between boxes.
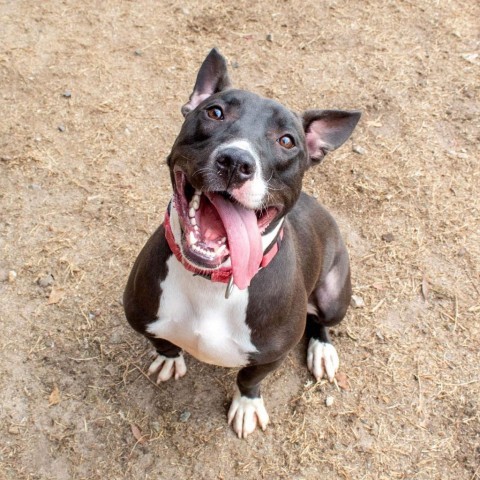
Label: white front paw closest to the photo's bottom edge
xmin=228 ymin=387 xmax=269 ymax=438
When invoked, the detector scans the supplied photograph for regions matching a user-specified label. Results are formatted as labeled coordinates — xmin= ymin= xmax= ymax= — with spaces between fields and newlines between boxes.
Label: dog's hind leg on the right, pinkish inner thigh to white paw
xmin=306 ymin=251 xmax=352 ymax=382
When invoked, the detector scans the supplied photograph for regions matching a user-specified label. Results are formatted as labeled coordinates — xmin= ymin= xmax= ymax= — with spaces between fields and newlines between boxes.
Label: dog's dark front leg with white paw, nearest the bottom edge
xmin=228 ymin=358 xmax=283 ymax=438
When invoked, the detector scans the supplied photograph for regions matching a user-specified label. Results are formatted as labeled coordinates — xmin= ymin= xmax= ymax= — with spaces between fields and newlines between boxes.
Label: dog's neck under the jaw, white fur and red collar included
xmin=163 ymin=202 xmax=285 ymax=291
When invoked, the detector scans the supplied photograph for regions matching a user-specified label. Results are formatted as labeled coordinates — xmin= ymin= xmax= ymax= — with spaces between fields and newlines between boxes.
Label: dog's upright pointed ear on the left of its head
xmin=182 ymin=48 xmax=230 ymax=117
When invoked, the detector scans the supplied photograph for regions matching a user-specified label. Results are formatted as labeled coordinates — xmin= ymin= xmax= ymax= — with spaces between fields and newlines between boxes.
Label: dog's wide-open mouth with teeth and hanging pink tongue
xmin=174 ymin=170 xmax=280 ymax=289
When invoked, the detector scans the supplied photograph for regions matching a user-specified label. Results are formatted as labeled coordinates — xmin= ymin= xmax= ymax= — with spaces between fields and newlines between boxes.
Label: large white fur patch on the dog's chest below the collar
xmin=147 ymin=255 xmax=257 ymax=367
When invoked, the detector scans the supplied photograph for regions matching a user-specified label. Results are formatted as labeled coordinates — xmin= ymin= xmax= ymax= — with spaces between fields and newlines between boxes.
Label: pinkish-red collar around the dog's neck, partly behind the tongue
xmin=163 ymin=205 xmax=283 ymax=283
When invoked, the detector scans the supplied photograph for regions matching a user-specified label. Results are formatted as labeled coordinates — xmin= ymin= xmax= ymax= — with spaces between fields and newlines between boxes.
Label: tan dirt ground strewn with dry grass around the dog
xmin=0 ymin=0 xmax=480 ymax=480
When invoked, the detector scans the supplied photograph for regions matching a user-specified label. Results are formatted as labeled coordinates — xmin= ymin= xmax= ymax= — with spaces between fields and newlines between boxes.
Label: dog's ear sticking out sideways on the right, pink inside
xmin=302 ymin=110 xmax=361 ymax=166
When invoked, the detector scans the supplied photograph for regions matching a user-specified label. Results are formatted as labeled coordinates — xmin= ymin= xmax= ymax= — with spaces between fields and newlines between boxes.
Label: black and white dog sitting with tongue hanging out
xmin=123 ymin=49 xmax=360 ymax=438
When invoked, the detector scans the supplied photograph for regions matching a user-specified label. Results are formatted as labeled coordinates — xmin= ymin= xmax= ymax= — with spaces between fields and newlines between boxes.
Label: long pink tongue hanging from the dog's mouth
xmin=208 ymin=194 xmax=263 ymax=290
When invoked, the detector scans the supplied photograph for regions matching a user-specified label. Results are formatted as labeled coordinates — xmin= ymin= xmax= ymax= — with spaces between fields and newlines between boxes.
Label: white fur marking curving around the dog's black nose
xmin=210 ymin=140 xmax=268 ymax=209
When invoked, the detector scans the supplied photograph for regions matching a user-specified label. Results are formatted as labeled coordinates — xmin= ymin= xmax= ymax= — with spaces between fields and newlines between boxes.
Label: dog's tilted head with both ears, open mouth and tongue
xmin=168 ymin=49 xmax=360 ymax=288
